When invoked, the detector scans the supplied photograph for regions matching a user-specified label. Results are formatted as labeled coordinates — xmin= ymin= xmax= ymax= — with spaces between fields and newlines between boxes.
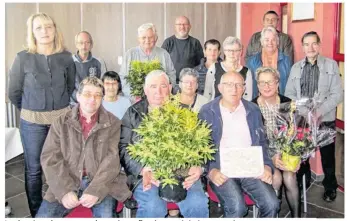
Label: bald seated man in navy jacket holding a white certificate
xmin=199 ymin=72 xmax=279 ymax=218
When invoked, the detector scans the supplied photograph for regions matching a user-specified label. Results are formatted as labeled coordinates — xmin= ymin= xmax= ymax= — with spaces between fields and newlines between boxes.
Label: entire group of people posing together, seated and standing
xmin=8 ymin=11 xmax=343 ymax=218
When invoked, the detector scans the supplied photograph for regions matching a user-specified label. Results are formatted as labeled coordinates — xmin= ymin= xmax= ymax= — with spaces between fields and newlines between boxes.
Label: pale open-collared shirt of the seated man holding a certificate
xmin=219 ymin=101 xmax=252 ymax=148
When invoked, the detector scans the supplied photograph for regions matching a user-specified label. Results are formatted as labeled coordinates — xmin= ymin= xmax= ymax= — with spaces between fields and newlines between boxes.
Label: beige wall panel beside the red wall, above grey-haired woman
xmin=206 ymin=3 xmax=236 ymax=47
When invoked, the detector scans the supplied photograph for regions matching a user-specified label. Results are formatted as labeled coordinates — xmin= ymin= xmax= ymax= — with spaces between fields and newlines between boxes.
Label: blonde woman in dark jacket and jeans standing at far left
xmin=8 ymin=13 xmax=75 ymax=217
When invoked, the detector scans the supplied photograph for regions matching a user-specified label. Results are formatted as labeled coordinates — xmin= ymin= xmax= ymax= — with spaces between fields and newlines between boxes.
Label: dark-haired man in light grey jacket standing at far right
xmin=285 ymin=31 xmax=343 ymax=202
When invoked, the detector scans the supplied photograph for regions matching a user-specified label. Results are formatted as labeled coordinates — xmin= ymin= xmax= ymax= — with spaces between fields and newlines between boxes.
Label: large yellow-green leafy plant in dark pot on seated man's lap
xmin=127 ymin=94 xmax=215 ymax=202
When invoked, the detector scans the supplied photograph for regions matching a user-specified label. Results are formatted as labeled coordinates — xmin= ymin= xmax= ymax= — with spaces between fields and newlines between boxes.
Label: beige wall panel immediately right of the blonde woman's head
xmin=39 ymin=3 xmax=81 ymax=53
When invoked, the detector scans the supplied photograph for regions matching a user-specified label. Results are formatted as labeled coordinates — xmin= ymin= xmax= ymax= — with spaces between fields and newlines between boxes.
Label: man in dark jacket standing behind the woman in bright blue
xmin=245 ymin=11 xmax=294 ymax=62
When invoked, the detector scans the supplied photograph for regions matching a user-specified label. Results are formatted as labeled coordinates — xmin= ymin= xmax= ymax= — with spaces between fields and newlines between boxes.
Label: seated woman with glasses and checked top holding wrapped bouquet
xmin=253 ymin=67 xmax=300 ymax=217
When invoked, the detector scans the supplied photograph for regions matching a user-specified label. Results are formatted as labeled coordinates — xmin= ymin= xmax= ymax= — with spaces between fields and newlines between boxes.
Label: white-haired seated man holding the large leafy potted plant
xmin=119 ymin=70 xmax=209 ymax=218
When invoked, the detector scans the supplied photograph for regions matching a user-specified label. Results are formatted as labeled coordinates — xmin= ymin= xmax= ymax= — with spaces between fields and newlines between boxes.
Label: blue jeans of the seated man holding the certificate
xmin=210 ymin=178 xmax=279 ymax=218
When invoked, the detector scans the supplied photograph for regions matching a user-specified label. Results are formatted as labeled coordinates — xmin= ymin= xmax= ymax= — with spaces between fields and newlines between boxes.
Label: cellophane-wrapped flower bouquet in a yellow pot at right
xmin=270 ymin=96 xmax=336 ymax=171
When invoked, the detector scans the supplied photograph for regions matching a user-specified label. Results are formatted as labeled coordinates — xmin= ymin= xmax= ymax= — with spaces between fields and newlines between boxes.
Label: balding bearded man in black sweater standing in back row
xmin=161 ymin=16 xmax=204 ymax=84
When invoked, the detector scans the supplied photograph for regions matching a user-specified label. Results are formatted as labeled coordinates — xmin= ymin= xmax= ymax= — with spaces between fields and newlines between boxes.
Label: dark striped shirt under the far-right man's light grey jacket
xmin=300 ymin=58 xmax=319 ymax=98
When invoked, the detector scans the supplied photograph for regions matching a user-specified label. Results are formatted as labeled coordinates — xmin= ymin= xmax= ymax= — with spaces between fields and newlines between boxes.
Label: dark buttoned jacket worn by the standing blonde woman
xmin=8 ymin=51 xmax=76 ymax=111
